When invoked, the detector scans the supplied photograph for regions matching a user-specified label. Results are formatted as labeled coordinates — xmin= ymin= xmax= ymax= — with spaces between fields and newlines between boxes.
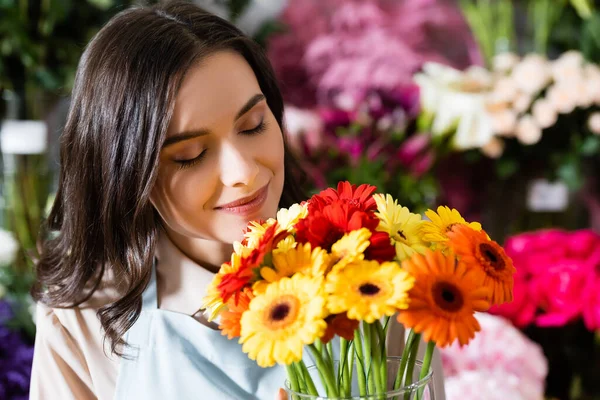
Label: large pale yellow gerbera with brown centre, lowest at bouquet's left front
xmin=240 ymin=274 xmax=327 ymax=367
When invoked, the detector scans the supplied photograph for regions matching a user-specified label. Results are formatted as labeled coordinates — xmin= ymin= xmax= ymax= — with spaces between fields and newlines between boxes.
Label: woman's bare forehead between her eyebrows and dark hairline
xmin=169 ymin=50 xmax=261 ymax=133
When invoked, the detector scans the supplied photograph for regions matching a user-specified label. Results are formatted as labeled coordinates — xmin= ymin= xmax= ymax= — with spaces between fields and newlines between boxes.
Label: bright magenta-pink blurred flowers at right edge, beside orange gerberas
xmin=491 ymin=229 xmax=600 ymax=327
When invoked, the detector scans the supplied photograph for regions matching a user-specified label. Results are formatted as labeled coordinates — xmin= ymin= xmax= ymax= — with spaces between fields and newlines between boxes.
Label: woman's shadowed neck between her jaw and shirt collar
xmin=166 ymin=228 xmax=233 ymax=273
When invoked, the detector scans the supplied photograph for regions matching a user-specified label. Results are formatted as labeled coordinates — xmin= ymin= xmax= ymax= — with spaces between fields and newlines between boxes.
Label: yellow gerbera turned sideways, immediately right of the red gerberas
xmin=373 ymin=193 xmax=428 ymax=261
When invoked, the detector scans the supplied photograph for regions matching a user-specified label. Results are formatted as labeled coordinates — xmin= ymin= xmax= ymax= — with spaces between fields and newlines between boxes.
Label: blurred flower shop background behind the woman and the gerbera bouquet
xmin=0 ymin=0 xmax=600 ymax=400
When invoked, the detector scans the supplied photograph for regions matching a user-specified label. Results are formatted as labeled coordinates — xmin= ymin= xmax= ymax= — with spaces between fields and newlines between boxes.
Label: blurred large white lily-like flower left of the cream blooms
xmin=414 ymin=63 xmax=493 ymax=149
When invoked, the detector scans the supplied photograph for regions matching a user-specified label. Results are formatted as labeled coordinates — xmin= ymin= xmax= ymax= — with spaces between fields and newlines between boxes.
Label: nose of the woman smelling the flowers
xmin=220 ymin=145 xmax=259 ymax=187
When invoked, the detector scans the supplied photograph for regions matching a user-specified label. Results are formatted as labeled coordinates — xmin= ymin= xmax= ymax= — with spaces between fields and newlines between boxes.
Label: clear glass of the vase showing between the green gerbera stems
xmin=284 ymin=357 xmax=435 ymax=400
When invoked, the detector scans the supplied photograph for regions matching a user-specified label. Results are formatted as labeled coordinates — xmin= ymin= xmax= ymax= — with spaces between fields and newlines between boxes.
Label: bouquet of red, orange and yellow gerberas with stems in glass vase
xmin=205 ymin=182 xmax=514 ymax=399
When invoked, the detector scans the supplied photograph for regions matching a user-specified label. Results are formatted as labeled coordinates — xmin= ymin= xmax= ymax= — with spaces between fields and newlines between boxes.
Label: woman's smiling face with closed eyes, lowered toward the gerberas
xmin=151 ymin=51 xmax=284 ymax=243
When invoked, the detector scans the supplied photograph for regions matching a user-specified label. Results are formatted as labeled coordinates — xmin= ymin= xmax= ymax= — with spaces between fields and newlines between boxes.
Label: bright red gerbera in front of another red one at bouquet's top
xmin=295 ymin=200 xmax=379 ymax=251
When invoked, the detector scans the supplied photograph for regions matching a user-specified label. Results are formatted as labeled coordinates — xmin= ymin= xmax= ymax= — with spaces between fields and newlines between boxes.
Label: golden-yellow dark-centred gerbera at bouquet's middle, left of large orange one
xmin=325 ymin=261 xmax=414 ymax=323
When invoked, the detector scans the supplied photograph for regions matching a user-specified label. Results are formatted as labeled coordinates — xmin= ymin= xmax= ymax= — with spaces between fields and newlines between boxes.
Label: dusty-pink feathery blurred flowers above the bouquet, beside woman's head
xmin=267 ymin=0 xmax=481 ymax=107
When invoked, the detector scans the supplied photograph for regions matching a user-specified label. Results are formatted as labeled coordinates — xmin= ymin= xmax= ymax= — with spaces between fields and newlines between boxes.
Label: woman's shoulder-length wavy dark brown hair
xmin=32 ymin=1 xmax=305 ymax=355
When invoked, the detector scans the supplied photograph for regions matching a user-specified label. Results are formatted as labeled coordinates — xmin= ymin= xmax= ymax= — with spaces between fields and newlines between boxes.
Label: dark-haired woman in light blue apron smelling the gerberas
xmin=31 ymin=2 xmax=446 ymax=400
